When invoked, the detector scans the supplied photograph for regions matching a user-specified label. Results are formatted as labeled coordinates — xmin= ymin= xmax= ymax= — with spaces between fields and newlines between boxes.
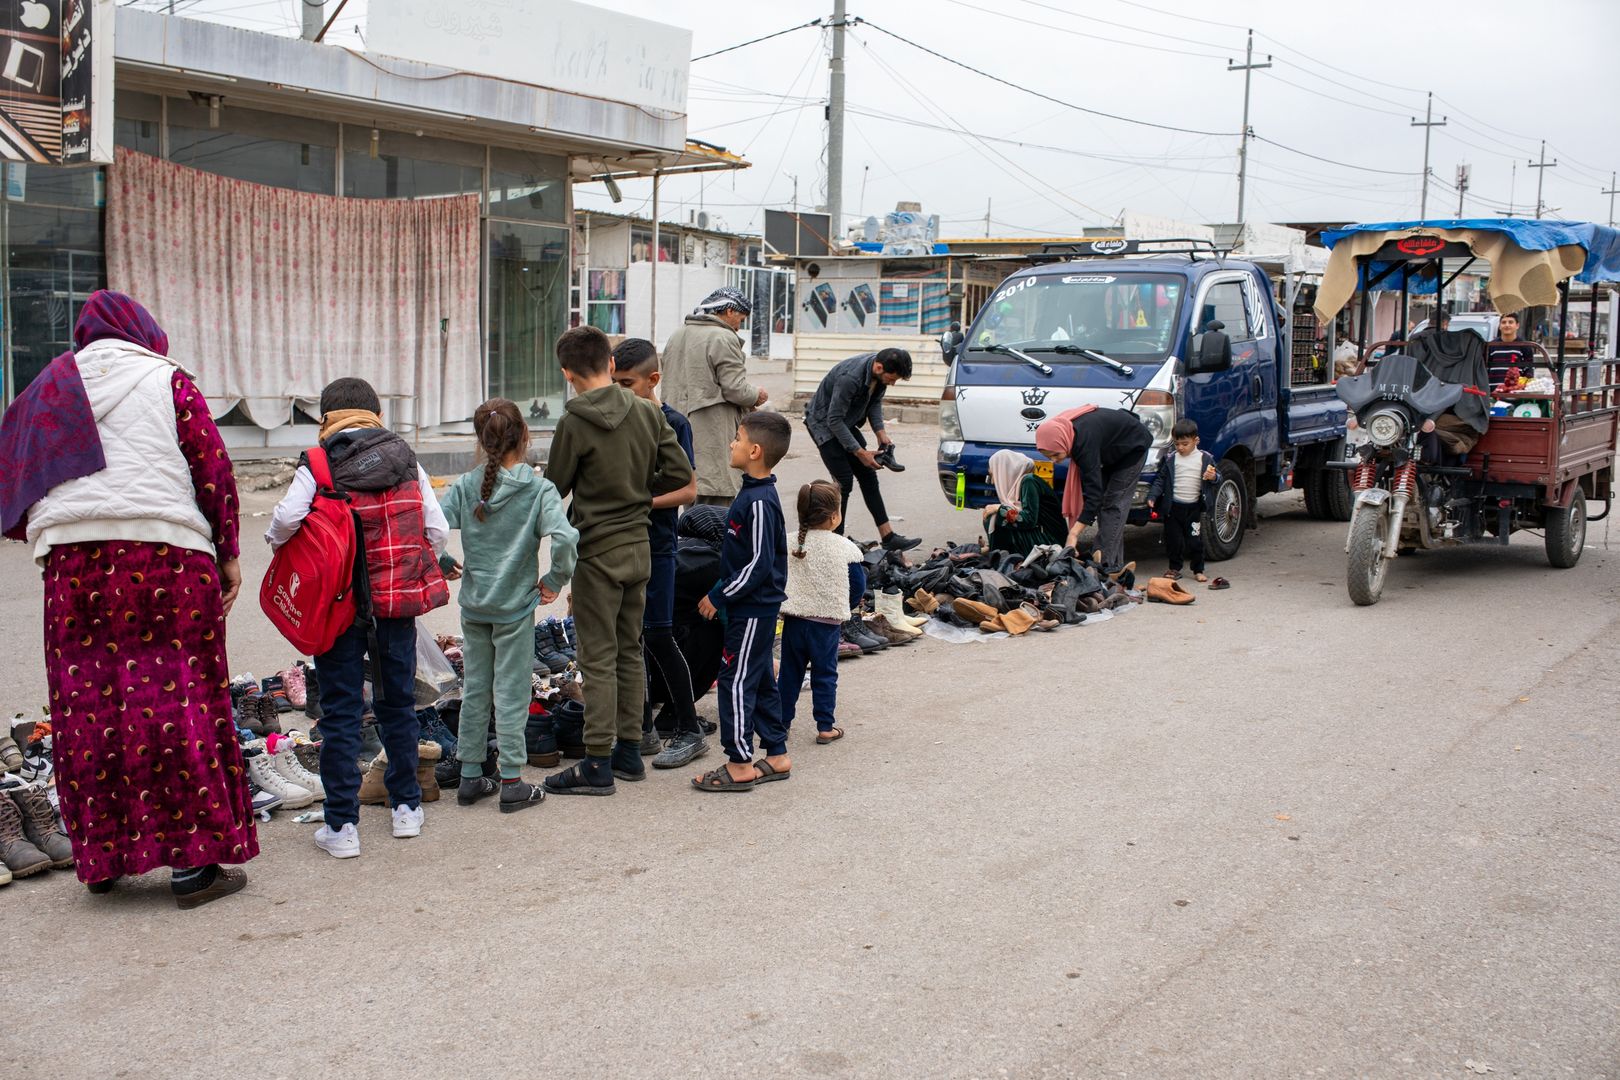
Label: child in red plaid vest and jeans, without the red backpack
xmin=264 ymin=379 xmax=450 ymax=858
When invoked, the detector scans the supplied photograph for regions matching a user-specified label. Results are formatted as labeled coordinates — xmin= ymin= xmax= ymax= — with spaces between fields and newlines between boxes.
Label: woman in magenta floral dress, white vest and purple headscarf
xmin=0 ymin=291 xmax=259 ymax=908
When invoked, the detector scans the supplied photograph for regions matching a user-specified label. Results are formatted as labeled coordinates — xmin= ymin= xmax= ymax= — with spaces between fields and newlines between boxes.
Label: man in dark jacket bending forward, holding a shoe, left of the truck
xmin=805 ymin=348 xmax=922 ymax=551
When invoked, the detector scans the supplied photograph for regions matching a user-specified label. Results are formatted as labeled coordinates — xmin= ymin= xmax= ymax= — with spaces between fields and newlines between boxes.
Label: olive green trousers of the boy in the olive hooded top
xmin=573 ymin=541 xmax=653 ymax=758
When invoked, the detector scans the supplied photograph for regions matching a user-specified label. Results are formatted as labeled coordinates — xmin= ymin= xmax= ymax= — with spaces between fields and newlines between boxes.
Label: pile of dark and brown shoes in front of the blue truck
xmin=839 ymin=544 xmax=1142 ymax=641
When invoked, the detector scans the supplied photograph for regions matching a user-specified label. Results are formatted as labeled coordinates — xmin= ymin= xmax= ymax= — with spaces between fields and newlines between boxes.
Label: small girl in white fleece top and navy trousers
xmin=776 ymin=479 xmax=867 ymax=746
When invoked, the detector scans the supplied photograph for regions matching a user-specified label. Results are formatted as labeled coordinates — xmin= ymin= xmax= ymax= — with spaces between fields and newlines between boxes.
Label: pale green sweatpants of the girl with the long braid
xmin=455 ymin=614 xmax=535 ymax=780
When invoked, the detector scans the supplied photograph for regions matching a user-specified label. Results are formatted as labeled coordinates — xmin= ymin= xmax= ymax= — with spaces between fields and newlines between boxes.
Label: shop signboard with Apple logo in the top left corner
xmin=0 ymin=0 xmax=115 ymax=165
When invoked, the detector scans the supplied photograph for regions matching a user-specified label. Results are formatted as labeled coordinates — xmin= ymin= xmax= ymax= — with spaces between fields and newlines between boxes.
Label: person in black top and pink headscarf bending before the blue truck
xmin=1035 ymin=405 xmax=1153 ymax=573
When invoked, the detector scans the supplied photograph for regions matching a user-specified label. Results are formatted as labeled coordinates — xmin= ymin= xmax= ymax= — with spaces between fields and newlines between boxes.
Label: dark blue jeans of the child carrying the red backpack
xmin=314 ymin=619 xmax=421 ymax=832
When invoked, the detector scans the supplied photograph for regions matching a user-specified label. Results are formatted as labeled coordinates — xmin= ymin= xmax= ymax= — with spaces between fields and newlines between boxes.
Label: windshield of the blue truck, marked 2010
xmin=967 ymin=272 xmax=1186 ymax=364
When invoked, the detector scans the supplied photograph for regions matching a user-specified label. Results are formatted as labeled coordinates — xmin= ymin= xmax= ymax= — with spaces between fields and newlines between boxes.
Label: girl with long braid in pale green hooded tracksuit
xmin=439 ymin=398 xmax=580 ymax=814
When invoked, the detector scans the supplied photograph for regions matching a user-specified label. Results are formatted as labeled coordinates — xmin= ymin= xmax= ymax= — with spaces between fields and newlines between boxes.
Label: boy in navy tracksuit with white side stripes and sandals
xmin=692 ymin=413 xmax=792 ymax=792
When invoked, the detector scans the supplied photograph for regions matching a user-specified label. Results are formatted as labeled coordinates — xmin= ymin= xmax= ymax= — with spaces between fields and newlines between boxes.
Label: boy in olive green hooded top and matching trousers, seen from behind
xmin=546 ymin=325 xmax=692 ymax=795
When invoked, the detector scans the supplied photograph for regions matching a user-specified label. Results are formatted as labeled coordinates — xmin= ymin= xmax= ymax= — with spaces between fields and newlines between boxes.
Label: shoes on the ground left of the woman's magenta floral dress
xmin=0 ymin=717 xmax=73 ymax=886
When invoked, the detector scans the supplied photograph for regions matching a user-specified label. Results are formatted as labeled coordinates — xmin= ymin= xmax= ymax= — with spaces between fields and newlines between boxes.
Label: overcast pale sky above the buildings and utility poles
xmin=152 ymin=0 xmax=1620 ymax=236
